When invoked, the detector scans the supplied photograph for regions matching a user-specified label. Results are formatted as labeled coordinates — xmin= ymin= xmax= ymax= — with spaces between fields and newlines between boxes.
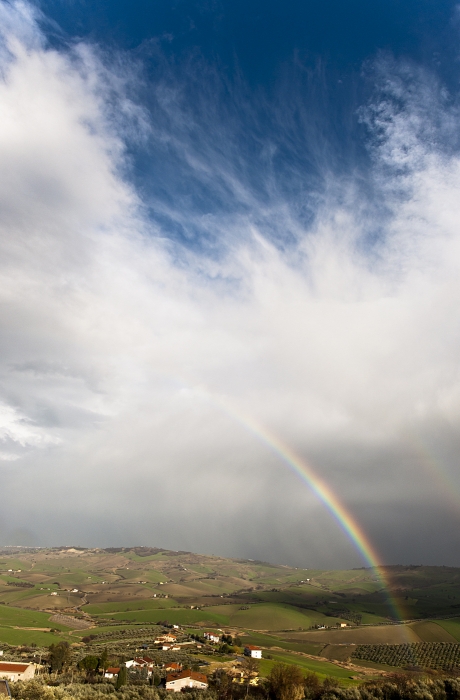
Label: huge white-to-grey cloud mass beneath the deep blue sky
xmin=0 ymin=3 xmax=460 ymax=563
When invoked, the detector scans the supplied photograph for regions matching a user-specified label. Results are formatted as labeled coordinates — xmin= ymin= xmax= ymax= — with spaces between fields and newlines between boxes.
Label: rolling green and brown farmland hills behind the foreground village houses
xmin=0 ymin=547 xmax=460 ymax=676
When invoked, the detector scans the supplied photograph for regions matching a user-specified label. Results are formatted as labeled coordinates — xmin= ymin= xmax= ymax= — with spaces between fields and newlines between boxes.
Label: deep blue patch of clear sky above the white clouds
xmin=36 ymin=0 xmax=458 ymax=254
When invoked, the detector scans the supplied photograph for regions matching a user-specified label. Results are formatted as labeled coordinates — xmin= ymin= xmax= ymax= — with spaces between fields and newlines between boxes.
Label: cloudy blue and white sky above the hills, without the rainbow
xmin=0 ymin=0 xmax=460 ymax=568
